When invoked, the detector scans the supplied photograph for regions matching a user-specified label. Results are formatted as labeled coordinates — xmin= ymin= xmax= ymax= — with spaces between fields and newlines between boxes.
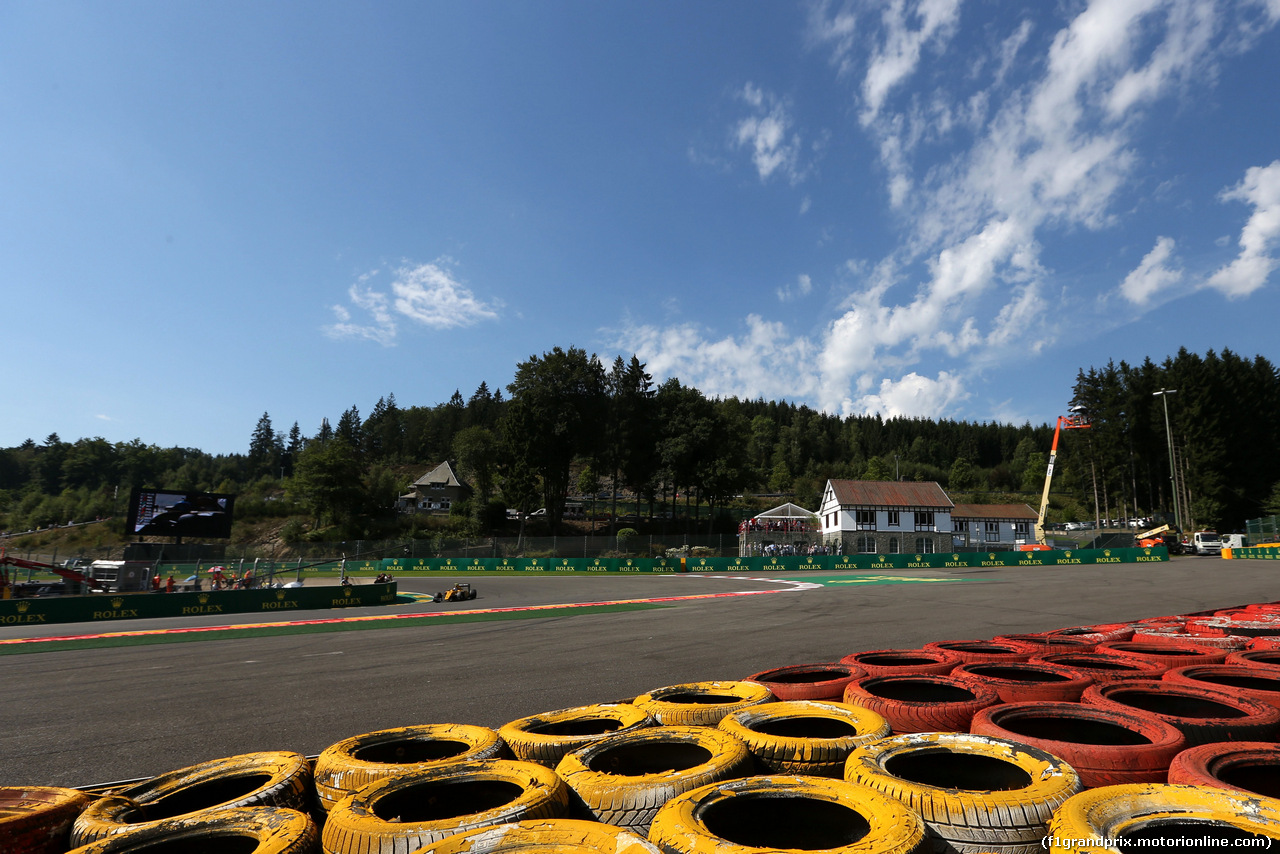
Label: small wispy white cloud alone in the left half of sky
xmin=324 ymin=259 xmax=498 ymax=347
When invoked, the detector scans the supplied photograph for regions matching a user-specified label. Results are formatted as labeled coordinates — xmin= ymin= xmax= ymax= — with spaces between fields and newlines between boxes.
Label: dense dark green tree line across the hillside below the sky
xmin=0 ymin=347 xmax=1280 ymax=535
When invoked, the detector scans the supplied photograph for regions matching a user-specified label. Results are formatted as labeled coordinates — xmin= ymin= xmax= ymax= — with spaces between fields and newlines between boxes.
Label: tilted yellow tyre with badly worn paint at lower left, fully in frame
xmin=72 ymin=752 xmax=315 ymax=846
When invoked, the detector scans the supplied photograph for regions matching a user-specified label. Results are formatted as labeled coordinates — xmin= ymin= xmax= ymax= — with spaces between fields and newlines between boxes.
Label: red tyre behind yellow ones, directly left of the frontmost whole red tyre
xmin=845 ymin=675 xmax=1000 ymax=734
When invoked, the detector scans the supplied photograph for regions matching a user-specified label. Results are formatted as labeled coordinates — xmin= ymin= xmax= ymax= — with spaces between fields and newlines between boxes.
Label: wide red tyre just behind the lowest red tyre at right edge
xmin=1080 ymin=680 xmax=1280 ymax=748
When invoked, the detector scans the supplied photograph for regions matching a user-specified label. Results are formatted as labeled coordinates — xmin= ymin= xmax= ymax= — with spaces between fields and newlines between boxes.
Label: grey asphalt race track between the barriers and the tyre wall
xmin=0 ymin=557 xmax=1280 ymax=786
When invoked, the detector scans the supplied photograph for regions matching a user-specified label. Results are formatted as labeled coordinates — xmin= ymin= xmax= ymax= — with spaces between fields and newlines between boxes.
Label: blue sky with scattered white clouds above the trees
xmin=0 ymin=0 xmax=1280 ymax=453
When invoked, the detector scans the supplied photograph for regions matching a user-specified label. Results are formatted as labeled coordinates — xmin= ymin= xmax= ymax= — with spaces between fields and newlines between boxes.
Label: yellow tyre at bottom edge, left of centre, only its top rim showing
xmin=417 ymin=818 xmax=660 ymax=854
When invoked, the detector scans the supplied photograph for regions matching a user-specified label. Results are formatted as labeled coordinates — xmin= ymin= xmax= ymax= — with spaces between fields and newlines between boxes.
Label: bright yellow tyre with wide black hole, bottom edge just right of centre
xmin=649 ymin=776 xmax=929 ymax=854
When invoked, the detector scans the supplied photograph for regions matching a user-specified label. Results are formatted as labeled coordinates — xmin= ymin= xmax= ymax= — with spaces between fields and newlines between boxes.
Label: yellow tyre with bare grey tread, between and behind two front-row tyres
xmin=556 ymin=726 xmax=753 ymax=835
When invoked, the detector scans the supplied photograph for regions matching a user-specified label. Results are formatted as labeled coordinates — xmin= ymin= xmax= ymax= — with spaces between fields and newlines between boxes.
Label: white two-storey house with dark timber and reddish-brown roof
xmin=818 ymin=480 xmax=954 ymax=554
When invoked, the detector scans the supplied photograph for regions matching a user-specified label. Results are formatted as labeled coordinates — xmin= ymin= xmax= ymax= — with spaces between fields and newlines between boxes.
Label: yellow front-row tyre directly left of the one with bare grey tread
xmin=320 ymin=759 xmax=570 ymax=854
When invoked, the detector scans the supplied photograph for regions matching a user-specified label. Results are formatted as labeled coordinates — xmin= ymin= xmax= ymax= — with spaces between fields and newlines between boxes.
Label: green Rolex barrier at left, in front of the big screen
xmin=0 ymin=581 xmax=396 ymax=626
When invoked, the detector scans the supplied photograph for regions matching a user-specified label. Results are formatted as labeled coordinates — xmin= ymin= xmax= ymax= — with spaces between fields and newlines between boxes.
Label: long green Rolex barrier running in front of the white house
xmin=373 ymin=547 xmax=1169 ymax=575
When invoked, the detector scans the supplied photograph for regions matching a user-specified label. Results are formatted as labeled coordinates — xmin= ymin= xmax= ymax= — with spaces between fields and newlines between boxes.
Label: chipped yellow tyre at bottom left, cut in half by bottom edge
xmin=64 ymin=807 xmax=320 ymax=854
